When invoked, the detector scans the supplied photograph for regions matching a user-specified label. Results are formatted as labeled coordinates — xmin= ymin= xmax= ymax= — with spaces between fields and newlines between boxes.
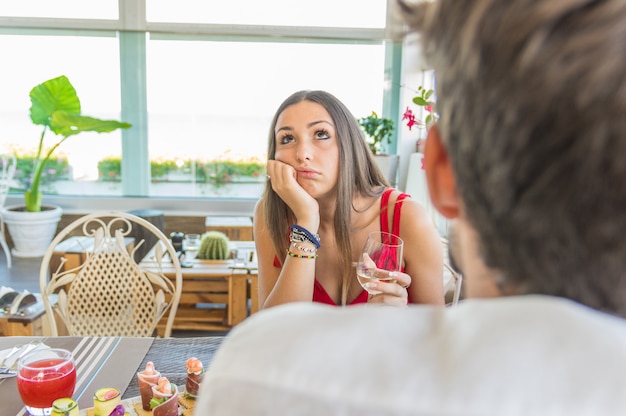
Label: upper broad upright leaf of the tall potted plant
xmin=30 ymin=75 xmax=81 ymax=126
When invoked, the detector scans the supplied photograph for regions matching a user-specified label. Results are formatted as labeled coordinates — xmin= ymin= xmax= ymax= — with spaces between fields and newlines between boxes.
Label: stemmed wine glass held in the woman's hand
xmin=356 ymin=231 xmax=404 ymax=295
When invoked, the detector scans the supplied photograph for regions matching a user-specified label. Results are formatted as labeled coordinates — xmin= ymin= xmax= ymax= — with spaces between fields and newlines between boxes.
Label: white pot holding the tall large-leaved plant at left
xmin=0 ymin=205 xmax=63 ymax=257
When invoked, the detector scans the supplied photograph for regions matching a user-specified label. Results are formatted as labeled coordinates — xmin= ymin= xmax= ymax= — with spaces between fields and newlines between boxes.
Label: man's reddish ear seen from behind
xmin=424 ymin=124 xmax=459 ymax=219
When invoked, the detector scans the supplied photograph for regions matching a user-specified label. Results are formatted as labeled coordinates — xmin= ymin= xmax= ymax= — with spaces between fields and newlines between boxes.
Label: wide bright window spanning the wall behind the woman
xmin=0 ymin=0 xmax=398 ymax=206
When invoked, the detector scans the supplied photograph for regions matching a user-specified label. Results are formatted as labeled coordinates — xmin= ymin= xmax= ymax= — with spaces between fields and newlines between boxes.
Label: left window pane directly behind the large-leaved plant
xmin=0 ymin=35 xmax=121 ymax=195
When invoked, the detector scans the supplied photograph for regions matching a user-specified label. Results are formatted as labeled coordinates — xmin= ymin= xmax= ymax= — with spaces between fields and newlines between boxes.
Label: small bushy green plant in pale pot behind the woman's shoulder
xmin=358 ymin=111 xmax=400 ymax=186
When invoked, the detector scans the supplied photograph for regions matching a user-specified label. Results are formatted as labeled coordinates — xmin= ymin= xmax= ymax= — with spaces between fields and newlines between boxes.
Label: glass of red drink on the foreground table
xmin=17 ymin=348 xmax=76 ymax=416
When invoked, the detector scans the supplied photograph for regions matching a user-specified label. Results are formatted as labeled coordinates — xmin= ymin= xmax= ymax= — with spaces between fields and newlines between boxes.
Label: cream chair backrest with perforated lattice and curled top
xmin=39 ymin=212 xmax=182 ymax=337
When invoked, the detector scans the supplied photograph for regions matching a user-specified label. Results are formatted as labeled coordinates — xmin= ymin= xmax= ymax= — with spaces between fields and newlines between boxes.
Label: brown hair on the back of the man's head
xmin=405 ymin=0 xmax=626 ymax=316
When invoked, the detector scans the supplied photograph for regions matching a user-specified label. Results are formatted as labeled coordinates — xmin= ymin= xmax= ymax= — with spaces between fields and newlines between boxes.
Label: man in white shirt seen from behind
xmin=198 ymin=0 xmax=626 ymax=415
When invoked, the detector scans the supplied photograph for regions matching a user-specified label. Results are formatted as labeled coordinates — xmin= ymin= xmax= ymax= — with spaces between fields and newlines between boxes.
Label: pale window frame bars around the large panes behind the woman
xmin=0 ymin=0 xmax=402 ymax=215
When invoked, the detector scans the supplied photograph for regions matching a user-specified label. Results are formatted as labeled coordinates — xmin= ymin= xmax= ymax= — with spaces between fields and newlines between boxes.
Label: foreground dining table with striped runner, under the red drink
xmin=0 ymin=337 xmax=223 ymax=416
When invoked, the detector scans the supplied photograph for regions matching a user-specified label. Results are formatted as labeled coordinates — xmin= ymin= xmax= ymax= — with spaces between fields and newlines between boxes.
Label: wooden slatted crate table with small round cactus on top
xmin=139 ymin=244 xmax=259 ymax=335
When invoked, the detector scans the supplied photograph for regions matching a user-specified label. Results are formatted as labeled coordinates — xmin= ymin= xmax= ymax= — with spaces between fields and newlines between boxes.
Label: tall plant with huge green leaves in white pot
xmin=1 ymin=75 xmax=131 ymax=257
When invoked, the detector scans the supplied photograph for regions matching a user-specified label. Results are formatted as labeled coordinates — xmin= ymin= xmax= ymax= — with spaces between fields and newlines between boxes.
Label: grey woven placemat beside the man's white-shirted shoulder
xmin=123 ymin=337 xmax=224 ymax=399
